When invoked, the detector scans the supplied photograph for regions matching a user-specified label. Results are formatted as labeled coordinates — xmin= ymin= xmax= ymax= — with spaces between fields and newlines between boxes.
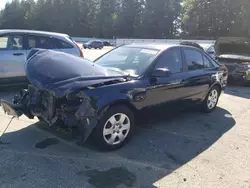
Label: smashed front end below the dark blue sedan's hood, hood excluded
xmin=1 ymin=85 xmax=107 ymax=142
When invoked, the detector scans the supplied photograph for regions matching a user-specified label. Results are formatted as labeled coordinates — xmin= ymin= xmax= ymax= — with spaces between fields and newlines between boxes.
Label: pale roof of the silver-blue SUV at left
xmin=0 ymin=29 xmax=69 ymax=37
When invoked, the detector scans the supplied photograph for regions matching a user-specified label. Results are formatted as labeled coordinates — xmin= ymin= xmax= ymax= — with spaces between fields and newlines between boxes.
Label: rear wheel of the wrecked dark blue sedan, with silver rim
xmin=202 ymin=86 xmax=220 ymax=113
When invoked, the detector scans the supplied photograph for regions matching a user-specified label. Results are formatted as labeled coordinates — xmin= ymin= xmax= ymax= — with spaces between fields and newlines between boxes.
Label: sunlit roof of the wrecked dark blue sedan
xmin=123 ymin=44 xmax=200 ymax=51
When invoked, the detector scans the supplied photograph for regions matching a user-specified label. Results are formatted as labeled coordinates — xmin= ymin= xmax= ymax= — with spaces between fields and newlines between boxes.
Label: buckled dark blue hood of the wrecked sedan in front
xmin=25 ymin=49 xmax=126 ymax=97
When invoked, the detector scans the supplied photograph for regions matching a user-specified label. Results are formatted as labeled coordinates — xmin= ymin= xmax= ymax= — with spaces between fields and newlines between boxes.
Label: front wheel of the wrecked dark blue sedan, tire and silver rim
xmin=93 ymin=106 xmax=135 ymax=151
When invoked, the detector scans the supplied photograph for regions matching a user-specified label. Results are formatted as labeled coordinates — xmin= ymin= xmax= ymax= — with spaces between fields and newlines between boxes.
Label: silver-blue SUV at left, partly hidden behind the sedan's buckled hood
xmin=0 ymin=30 xmax=83 ymax=86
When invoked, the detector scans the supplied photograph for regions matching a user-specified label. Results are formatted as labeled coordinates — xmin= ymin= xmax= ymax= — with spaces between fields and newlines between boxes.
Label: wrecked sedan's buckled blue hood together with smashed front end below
xmin=1 ymin=50 xmax=127 ymax=141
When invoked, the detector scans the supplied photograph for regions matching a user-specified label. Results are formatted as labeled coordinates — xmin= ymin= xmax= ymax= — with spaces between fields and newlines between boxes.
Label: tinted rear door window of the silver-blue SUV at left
xmin=28 ymin=35 xmax=56 ymax=49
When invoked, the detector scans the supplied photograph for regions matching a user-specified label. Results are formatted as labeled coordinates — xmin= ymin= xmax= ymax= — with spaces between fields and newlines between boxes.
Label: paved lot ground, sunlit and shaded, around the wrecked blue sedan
xmin=0 ymin=50 xmax=250 ymax=188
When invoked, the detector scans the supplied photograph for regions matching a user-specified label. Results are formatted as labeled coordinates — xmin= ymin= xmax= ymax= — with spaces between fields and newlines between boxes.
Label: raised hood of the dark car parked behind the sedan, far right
xmin=215 ymin=37 xmax=250 ymax=59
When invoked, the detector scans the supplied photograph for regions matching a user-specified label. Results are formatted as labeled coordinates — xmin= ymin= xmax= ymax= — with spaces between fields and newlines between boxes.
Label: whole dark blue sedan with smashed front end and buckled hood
xmin=1 ymin=45 xmax=228 ymax=150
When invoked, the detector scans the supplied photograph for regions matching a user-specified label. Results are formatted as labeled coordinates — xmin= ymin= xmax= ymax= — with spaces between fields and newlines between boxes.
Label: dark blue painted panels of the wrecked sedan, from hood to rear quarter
xmin=26 ymin=47 xmax=227 ymax=111
